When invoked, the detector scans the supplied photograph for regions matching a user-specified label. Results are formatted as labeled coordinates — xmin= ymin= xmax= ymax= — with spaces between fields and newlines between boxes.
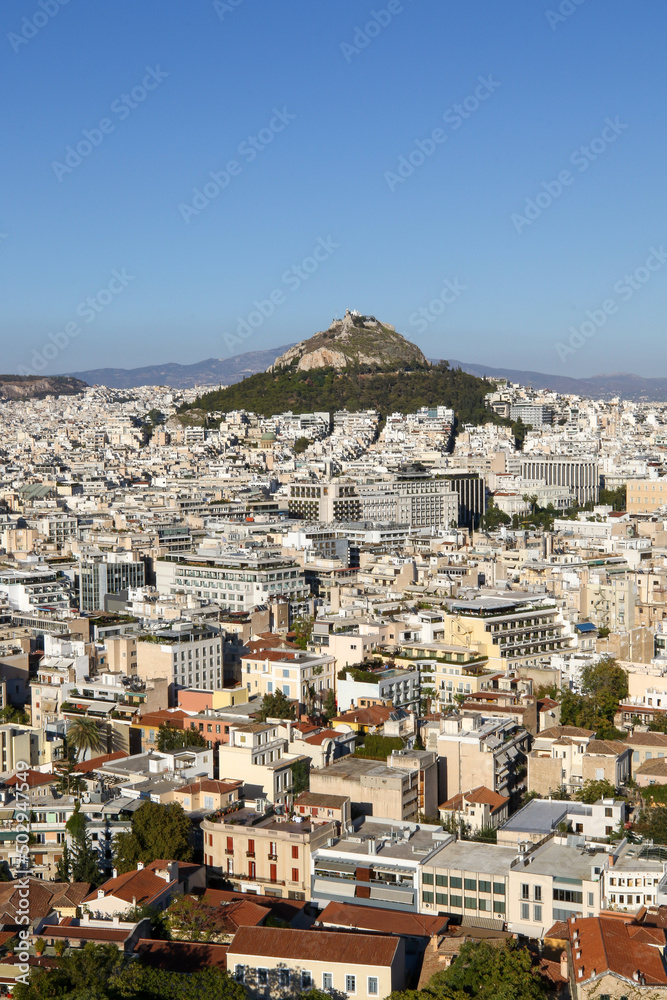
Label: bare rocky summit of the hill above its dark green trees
xmin=267 ymin=309 xmax=429 ymax=371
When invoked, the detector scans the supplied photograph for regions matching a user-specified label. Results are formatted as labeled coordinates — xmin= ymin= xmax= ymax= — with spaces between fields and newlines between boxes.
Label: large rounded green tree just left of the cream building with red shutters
xmin=115 ymin=802 xmax=192 ymax=873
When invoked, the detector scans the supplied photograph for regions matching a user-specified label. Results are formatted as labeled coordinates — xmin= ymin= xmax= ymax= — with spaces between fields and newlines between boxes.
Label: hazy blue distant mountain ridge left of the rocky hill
xmin=66 ymin=344 xmax=291 ymax=389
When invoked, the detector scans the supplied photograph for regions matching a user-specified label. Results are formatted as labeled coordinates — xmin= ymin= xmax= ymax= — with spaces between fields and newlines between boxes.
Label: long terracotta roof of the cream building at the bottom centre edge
xmin=229 ymin=927 xmax=399 ymax=967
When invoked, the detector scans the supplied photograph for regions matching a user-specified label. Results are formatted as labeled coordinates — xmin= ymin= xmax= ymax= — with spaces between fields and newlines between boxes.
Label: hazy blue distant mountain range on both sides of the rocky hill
xmin=62 ymin=344 xmax=667 ymax=402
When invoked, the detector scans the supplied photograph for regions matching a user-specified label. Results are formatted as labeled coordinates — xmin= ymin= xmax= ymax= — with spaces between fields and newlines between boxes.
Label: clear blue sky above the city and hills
xmin=0 ymin=0 xmax=667 ymax=376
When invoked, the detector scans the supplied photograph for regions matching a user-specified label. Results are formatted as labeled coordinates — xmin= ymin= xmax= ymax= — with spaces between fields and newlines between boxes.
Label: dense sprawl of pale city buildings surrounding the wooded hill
xmin=0 ymin=311 xmax=667 ymax=998
